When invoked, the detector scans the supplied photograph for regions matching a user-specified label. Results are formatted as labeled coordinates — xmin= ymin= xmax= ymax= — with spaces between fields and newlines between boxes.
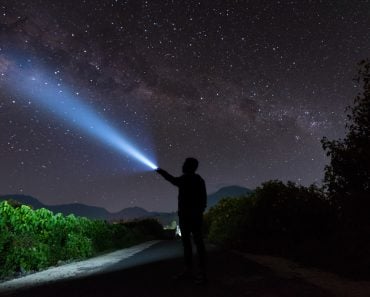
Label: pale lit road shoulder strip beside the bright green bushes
xmin=0 ymin=240 xmax=159 ymax=293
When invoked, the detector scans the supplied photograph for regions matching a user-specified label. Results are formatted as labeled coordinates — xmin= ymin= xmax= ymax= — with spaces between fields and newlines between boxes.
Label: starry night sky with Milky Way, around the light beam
xmin=0 ymin=0 xmax=370 ymax=212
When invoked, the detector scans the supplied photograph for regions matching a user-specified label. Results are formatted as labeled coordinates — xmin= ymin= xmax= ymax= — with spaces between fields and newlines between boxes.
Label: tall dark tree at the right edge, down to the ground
xmin=322 ymin=59 xmax=370 ymax=273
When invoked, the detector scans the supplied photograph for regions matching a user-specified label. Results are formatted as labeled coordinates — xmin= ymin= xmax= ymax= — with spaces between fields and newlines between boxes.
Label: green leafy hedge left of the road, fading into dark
xmin=0 ymin=201 xmax=162 ymax=277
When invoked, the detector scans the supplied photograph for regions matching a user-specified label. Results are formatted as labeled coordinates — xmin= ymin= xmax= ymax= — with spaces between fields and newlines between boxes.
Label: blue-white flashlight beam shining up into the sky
xmin=1 ymin=56 xmax=158 ymax=170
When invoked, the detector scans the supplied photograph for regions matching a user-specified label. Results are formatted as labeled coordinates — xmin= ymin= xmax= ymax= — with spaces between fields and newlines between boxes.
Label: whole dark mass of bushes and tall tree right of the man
xmin=205 ymin=60 xmax=370 ymax=276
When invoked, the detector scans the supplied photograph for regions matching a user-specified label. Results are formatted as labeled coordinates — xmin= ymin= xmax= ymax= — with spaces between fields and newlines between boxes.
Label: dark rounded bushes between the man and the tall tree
xmin=205 ymin=180 xmax=334 ymax=251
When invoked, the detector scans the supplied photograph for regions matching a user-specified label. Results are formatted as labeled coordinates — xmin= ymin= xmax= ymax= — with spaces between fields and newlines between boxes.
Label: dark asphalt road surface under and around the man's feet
xmin=2 ymin=241 xmax=331 ymax=297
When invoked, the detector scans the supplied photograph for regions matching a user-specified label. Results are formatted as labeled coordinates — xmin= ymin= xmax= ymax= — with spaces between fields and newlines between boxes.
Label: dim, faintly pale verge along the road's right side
xmin=235 ymin=252 xmax=370 ymax=297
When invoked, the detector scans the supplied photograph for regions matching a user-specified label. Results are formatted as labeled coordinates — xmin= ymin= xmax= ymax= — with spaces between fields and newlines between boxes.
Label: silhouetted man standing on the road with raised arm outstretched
xmin=156 ymin=158 xmax=207 ymax=283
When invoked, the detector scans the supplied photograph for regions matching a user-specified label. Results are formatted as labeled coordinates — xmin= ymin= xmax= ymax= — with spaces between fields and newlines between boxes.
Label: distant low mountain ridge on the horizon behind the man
xmin=0 ymin=186 xmax=252 ymax=220
